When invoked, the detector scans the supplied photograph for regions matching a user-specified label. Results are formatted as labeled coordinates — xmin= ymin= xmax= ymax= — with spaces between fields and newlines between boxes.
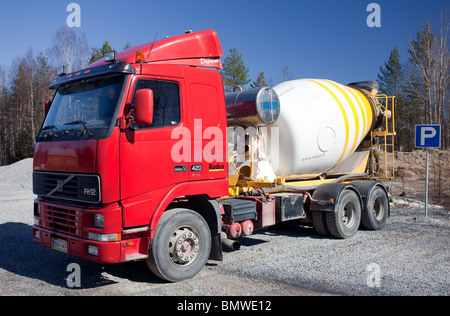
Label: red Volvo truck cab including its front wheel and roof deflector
xmin=33 ymin=31 xmax=228 ymax=281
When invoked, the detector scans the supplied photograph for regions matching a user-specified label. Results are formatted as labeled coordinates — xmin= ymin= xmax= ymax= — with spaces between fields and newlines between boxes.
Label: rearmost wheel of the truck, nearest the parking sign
xmin=361 ymin=186 xmax=389 ymax=230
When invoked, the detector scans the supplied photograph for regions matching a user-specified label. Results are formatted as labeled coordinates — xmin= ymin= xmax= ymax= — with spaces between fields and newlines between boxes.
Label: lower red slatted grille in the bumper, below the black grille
xmin=40 ymin=203 xmax=83 ymax=237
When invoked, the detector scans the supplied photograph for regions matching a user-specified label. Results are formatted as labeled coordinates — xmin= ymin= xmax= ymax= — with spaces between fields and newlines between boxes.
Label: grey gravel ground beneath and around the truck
xmin=0 ymin=159 xmax=450 ymax=296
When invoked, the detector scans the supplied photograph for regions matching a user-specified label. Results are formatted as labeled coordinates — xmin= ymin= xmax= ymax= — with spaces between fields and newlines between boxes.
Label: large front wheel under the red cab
xmin=147 ymin=208 xmax=211 ymax=282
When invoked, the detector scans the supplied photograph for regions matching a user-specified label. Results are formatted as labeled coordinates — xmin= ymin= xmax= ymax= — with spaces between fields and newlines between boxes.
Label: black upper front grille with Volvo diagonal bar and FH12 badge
xmin=33 ymin=171 xmax=101 ymax=203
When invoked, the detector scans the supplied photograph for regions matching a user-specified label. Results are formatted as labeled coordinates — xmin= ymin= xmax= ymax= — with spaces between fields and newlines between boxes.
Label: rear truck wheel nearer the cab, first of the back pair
xmin=326 ymin=190 xmax=361 ymax=239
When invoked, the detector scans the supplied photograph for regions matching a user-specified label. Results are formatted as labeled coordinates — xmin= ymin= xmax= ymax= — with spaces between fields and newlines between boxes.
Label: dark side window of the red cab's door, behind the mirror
xmin=131 ymin=80 xmax=181 ymax=129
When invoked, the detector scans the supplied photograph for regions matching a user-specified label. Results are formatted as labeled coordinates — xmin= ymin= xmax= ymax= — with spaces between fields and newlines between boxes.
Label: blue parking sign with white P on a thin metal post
xmin=416 ymin=125 xmax=441 ymax=217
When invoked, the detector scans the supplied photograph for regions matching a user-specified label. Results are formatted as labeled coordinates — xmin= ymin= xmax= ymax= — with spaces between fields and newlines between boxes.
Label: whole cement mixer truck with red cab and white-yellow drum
xmin=33 ymin=30 xmax=395 ymax=282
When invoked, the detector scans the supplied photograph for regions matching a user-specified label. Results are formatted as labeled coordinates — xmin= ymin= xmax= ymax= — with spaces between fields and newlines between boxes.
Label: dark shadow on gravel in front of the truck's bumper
xmin=0 ymin=222 xmax=162 ymax=295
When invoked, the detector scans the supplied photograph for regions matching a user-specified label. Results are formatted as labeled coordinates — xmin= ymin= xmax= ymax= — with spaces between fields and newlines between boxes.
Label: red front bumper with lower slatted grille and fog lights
xmin=33 ymin=200 xmax=150 ymax=263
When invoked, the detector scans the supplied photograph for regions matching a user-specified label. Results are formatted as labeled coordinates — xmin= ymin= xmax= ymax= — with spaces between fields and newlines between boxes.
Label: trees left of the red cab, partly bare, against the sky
xmin=0 ymin=27 xmax=125 ymax=165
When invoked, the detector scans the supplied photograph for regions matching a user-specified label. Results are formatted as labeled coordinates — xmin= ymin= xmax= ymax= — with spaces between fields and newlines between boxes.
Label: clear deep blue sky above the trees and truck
xmin=0 ymin=0 xmax=449 ymax=84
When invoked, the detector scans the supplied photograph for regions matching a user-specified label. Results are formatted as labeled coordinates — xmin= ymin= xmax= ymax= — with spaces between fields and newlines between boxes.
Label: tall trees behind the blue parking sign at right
xmin=378 ymin=12 xmax=450 ymax=151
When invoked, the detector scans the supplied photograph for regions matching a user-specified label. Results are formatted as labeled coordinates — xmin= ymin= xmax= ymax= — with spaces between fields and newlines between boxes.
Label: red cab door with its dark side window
xmin=120 ymin=76 xmax=188 ymax=201
